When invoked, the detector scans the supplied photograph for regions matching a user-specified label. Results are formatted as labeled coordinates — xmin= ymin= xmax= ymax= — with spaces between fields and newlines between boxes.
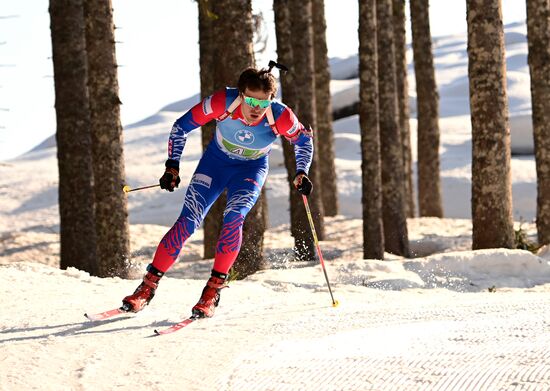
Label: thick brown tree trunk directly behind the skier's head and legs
xmin=199 ymin=0 xmax=267 ymax=278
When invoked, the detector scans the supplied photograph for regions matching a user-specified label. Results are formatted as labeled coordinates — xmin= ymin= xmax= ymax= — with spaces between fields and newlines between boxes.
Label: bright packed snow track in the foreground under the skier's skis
xmin=0 ymin=261 xmax=550 ymax=391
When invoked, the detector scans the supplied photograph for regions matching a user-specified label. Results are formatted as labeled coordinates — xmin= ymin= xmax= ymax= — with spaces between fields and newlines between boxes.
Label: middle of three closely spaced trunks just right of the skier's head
xmin=290 ymin=0 xmax=325 ymax=260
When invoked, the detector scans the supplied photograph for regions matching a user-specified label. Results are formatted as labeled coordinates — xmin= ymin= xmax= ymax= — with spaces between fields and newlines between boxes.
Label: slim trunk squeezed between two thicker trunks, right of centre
xmin=393 ymin=0 xmax=415 ymax=217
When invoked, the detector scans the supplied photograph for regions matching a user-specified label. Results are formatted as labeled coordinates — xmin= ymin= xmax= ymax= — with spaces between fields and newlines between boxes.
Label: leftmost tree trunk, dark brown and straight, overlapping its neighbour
xmin=50 ymin=0 xmax=98 ymax=276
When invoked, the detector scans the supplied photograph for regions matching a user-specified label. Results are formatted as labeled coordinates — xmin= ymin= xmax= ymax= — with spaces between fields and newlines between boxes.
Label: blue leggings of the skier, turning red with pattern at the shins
xmin=153 ymin=142 xmax=269 ymax=274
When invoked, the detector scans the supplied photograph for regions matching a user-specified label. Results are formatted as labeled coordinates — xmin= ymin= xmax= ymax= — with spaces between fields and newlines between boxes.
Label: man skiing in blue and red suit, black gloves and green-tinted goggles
xmin=122 ymin=62 xmax=313 ymax=317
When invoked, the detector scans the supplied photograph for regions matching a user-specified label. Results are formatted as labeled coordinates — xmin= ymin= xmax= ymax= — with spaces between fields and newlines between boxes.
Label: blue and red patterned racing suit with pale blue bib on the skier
xmin=153 ymin=88 xmax=313 ymax=274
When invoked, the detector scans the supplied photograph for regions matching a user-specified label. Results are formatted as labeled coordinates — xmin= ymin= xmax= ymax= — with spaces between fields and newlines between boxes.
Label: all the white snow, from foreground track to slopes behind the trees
xmin=0 ymin=24 xmax=550 ymax=391
